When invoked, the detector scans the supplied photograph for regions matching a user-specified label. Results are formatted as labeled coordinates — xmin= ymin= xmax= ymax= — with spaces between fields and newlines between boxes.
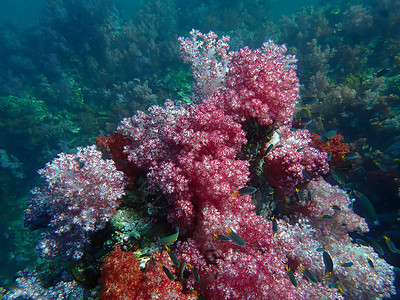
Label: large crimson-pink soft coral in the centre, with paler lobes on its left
xmin=118 ymin=101 xmax=249 ymax=233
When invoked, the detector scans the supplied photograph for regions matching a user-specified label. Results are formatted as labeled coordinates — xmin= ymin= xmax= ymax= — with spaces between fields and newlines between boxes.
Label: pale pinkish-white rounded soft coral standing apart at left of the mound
xmin=25 ymin=145 xmax=125 ymax=259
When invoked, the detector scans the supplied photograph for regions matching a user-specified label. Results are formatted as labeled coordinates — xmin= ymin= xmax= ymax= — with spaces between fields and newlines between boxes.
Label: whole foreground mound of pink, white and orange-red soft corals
xmin=20 ymin=30 xmax=396 ymax=299
